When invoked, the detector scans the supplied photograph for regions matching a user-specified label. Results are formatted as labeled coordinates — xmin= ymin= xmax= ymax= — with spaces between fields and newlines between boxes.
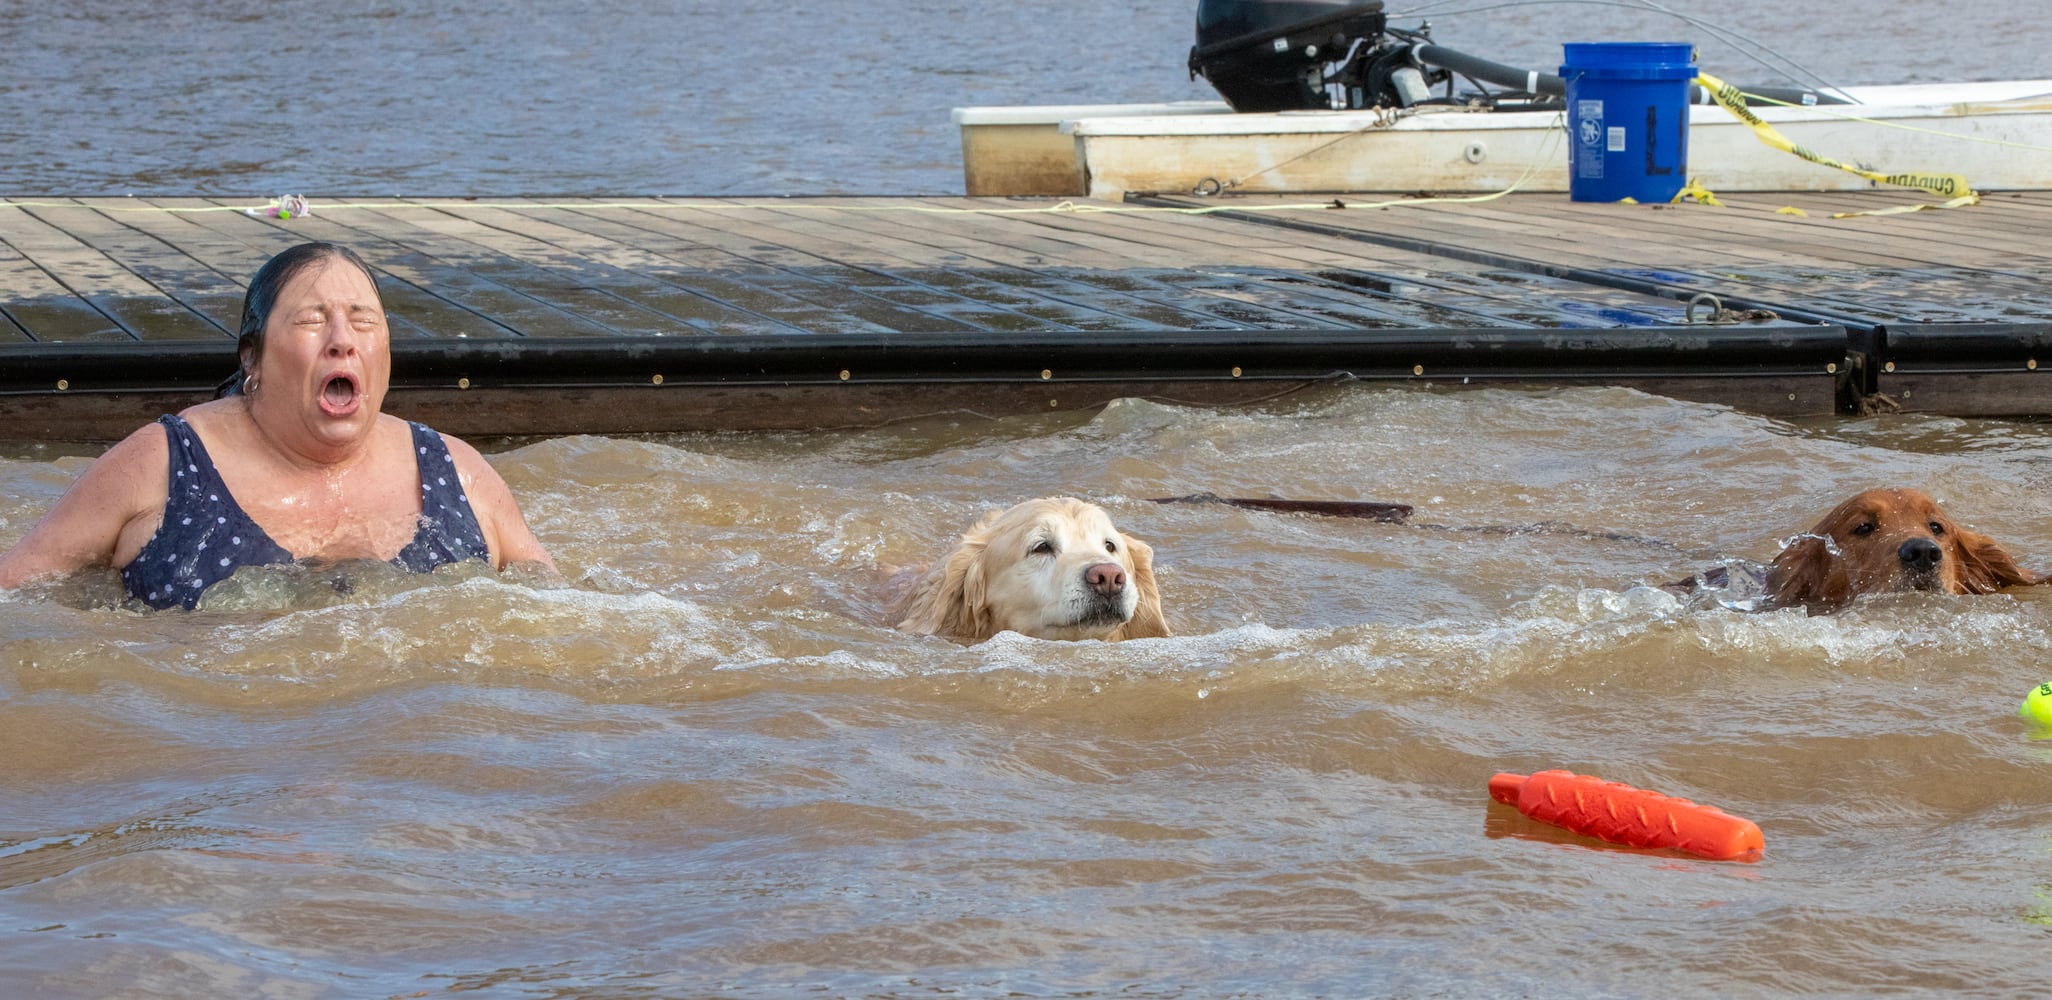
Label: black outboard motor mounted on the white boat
xmin=1190 ymin=0 xmax=1387 ymax=111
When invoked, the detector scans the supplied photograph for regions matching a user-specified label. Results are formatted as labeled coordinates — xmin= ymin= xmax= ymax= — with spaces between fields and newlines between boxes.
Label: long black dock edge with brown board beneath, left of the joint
xmin=0 ymin=324 xmax=1857 ymax=439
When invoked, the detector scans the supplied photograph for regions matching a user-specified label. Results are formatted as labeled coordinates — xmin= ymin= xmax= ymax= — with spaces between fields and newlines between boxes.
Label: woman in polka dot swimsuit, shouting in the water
xmin=0 ymin=242 xmax=556 ymax=608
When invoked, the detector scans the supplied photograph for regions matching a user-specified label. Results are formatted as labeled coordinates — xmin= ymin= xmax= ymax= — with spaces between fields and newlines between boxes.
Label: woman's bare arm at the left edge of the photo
xmin=0 ymin=423 xmax=170 ymax=589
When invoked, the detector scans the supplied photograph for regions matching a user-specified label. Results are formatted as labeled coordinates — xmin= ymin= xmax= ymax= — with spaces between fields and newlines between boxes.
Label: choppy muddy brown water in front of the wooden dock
xmin=0 ymin=386 xmax=2052 ymax=996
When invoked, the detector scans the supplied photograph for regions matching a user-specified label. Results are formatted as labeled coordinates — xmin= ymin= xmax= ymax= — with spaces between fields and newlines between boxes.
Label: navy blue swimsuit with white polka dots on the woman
xmin=121 ymin=415 xmax=490 ymax=608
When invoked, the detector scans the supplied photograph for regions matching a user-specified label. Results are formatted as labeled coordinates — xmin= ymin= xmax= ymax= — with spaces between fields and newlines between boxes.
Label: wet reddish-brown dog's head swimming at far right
xmin=1767 ymin=489 xmax=2044 ymax=612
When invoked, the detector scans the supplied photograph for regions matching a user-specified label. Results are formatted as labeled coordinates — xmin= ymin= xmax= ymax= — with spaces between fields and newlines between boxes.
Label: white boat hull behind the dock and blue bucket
xmin=956 ymin=80 xmax=2052 ymax=199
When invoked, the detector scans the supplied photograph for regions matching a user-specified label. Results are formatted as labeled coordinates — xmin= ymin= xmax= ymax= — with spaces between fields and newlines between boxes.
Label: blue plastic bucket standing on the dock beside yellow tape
xmin=1560 ymin=41 xmax=1695 ymax=201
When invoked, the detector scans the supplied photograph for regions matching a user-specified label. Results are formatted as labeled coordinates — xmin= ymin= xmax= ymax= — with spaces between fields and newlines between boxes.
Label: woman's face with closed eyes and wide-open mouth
xmin=250 ymin=257 xmax=392 ymax=458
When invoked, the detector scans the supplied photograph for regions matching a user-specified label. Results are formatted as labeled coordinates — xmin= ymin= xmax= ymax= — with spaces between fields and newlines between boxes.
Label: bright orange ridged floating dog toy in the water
xmin=1490 ymin=770 xmax=1767 ymax=860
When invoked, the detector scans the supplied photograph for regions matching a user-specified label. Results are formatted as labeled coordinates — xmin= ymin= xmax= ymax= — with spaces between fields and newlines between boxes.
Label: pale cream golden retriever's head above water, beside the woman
xmin=895 ymin=497 xmax=1170 ymax=643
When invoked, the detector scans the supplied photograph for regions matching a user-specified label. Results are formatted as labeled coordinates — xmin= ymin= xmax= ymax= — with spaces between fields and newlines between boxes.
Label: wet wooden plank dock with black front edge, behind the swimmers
xmin=0 ymin=191 xmax=2052 ymax=439
